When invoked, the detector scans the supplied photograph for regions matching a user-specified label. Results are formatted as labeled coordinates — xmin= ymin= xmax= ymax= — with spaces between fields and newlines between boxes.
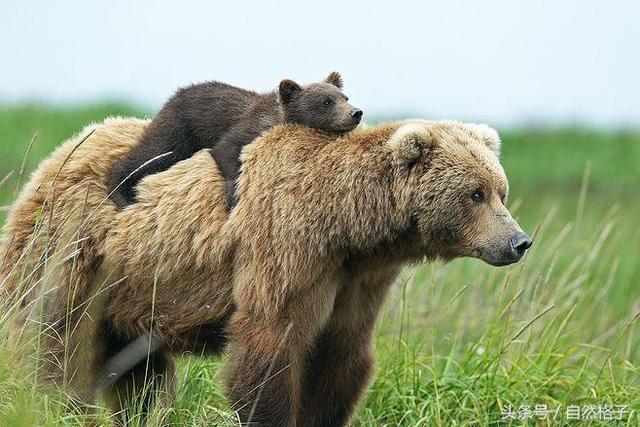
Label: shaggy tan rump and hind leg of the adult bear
xmin=0 ymin=118 xmax=155 ymax=401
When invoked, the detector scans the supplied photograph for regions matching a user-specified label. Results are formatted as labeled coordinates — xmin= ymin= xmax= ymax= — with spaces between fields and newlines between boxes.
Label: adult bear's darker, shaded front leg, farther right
xmin=298 ymin=274 xmax=395 ymax=427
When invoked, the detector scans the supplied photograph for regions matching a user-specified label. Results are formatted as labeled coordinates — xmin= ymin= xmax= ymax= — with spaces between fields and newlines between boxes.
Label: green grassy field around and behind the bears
xmin=0 ymin=104 xmax=640 ymax=426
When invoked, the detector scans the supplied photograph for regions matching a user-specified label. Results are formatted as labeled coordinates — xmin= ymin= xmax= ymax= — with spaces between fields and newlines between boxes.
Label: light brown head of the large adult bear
xmin=388 ymin=120 xmax=532 ymax=266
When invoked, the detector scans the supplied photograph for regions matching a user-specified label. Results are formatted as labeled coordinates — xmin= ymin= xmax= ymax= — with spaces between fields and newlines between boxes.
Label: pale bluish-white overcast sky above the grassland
xmin=0 ymin=0 xmax=640 ymax=126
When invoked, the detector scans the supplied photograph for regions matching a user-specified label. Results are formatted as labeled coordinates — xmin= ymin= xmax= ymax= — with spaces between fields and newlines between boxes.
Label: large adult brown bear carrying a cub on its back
xmin=0 ymin=120 xmax=531 ymax=426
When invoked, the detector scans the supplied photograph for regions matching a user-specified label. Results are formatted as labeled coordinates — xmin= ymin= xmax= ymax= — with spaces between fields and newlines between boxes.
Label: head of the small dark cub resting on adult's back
xmin=278 ymin=72 xmax=362 ymax=133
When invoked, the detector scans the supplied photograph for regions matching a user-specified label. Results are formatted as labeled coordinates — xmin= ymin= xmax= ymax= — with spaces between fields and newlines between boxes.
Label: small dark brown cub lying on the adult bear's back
xmin=107 ymin=72 xmax=362 ymax=209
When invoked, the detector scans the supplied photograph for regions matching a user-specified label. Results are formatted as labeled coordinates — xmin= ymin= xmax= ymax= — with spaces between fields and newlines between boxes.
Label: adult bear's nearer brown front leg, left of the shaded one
xmin=227 ymin=285 xmax=335 ymax=426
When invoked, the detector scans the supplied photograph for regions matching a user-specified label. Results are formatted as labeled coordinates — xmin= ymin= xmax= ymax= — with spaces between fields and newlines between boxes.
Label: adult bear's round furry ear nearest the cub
xmin=387 ymin=123 xmax=433 ymax=166
